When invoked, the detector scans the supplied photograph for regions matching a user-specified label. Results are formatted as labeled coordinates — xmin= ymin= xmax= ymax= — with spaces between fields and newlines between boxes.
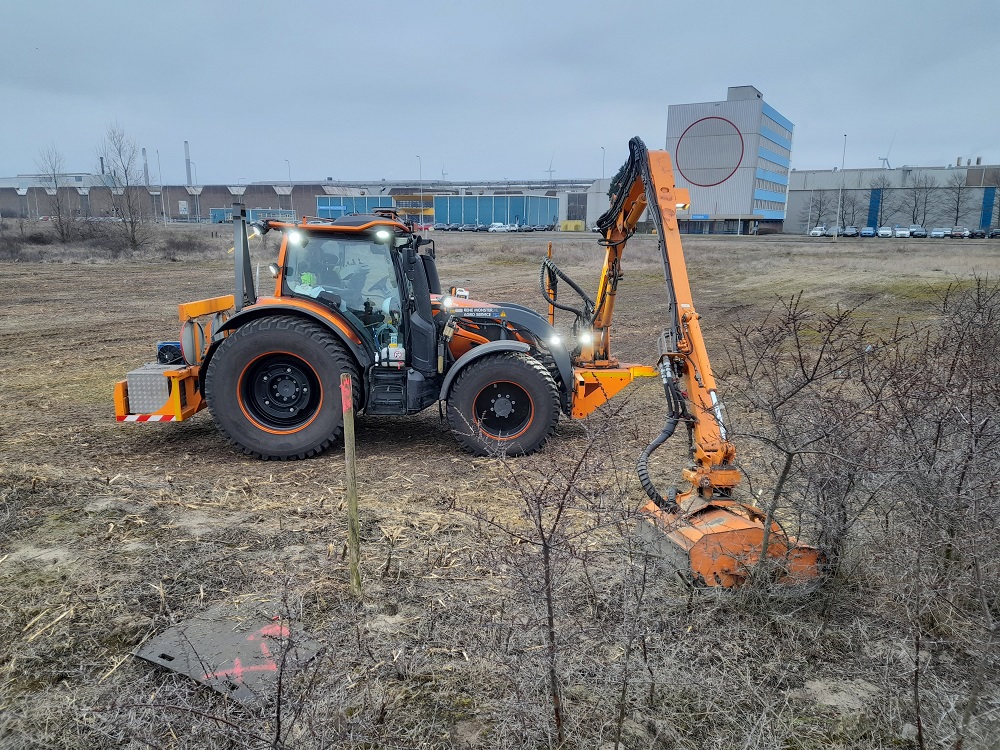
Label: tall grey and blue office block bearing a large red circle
xmin=666 ymin=86 xmax=795 ymax=234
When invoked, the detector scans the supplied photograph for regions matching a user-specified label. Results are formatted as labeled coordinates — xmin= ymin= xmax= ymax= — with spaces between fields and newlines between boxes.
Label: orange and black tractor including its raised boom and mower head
xmin=115 ymin=138 xmax=820 ymax=586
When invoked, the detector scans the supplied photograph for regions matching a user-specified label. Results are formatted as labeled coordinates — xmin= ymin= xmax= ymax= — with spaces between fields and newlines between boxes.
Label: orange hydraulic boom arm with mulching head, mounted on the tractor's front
xmin=574 ymin=138 xmax=820 ymax=586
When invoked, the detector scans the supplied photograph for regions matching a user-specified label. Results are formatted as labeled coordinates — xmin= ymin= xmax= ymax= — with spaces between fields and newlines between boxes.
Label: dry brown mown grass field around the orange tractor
xmin=0 ymin=228 xmax=1000 ymax=749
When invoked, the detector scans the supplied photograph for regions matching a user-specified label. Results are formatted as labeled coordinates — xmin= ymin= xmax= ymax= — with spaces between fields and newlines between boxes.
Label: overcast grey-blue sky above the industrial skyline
xmin=0 ymin=0 xmax=1000 ymax=183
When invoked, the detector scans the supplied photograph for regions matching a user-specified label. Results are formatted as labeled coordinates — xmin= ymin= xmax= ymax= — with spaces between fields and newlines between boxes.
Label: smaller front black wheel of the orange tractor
xmin=448 ymin=352 xmax=559 ymax=456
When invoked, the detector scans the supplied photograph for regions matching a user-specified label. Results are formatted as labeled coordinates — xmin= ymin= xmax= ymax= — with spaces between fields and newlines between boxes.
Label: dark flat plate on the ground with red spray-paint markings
xmin=135 ymin=607 xmax=320 ymax=705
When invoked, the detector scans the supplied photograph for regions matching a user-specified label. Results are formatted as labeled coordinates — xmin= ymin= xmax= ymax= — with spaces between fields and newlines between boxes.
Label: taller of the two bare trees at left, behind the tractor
xmin=98 ymin=123 xmax=153 ymax=251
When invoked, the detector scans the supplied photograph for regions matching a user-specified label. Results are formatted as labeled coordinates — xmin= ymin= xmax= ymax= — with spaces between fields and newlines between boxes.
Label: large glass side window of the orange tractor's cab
xmin=284 ymin=232 xmax=402 ymax=348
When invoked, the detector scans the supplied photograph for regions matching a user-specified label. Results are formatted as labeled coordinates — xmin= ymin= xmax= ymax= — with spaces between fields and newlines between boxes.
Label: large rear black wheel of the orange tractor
xmin=205 ymin=317 xmax=361 ymax=461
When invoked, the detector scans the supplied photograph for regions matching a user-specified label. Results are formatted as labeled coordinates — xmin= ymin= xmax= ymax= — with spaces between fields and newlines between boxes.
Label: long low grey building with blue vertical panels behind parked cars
xmin=784 ymin=159 xmax=1000 ymax=234
